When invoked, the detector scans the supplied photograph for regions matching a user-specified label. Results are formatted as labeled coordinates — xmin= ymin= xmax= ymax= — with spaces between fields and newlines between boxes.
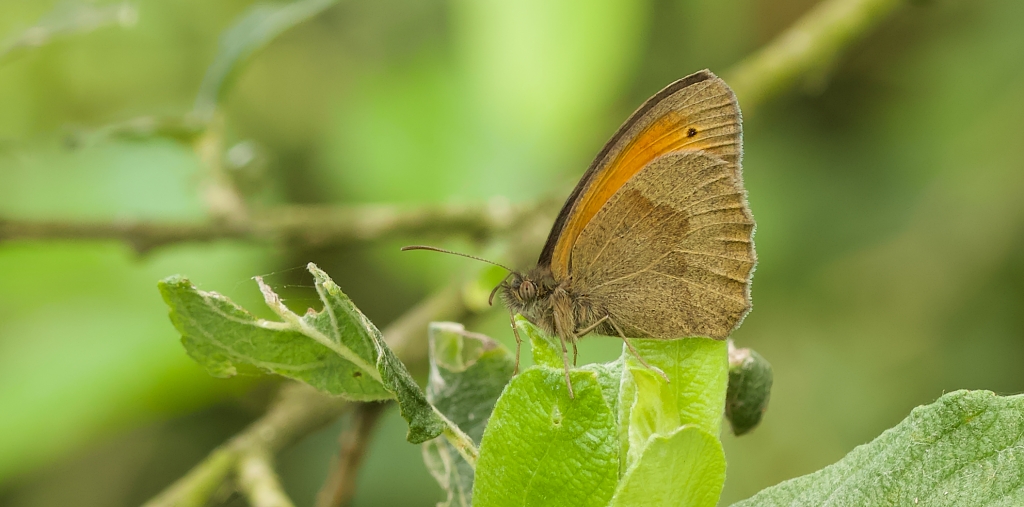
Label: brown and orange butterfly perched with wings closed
xmin=406 ymin=71 xmax=756 ymax=396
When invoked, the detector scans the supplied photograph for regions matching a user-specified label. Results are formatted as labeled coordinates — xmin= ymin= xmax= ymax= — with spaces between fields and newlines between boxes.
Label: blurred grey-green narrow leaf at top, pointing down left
xmin=195 ymin=0 xmax=337 ymax=118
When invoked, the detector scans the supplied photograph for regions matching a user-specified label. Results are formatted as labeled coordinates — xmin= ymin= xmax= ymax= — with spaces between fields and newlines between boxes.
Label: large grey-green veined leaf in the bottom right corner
xmin=733 ymin=391 xmax=1024 ymax=507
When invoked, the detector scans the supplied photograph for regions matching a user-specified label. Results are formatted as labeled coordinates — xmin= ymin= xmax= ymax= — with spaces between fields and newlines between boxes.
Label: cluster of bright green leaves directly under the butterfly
xmin=474 ymin=316 xmax=728 ymax=506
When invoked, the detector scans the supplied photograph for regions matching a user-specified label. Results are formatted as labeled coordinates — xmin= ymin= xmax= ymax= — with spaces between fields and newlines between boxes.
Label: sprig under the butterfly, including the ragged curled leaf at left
xmin=160 ymin=270 xmax=727 ymax=506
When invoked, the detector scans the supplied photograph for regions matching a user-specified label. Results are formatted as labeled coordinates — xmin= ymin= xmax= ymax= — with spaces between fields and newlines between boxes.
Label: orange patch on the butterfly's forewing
xmin=551 ymin=112 xmax=703 ymax=280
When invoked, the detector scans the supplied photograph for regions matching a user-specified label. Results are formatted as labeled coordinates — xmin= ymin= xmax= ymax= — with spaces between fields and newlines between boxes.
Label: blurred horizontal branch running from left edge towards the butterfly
xmin=0 ymin=199 xmax=537 ymax=253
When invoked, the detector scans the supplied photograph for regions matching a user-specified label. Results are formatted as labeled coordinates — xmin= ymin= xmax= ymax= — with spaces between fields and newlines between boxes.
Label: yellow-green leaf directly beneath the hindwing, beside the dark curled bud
xmin=618 ymin=338 xmax=729 ymax=469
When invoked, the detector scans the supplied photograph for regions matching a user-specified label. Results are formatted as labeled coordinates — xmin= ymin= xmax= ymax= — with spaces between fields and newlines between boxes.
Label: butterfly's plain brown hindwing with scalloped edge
xmin=570 ymin=151 xmax=756 ymax=338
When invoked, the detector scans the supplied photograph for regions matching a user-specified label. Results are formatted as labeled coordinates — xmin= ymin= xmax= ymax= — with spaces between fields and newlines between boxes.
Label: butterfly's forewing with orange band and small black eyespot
xmin=540 ymin=71 xmax=741 ymax=280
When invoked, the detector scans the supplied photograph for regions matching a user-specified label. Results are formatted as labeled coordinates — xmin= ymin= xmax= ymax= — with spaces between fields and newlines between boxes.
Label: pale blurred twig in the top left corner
xmin=0 ymin=1 xmax=138 ymax=65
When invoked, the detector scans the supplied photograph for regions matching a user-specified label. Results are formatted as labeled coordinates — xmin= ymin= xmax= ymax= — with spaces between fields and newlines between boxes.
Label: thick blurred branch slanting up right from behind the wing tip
xmin=725 ymin=0 xmax=907 ymax=112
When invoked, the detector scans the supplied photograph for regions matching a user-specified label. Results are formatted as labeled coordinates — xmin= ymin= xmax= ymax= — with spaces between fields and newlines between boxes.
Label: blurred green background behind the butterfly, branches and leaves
xmin=0 ymin=0 xmax=1024 ymax=507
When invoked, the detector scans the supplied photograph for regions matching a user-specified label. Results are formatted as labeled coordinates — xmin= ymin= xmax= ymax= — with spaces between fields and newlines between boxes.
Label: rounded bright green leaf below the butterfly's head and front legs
xmin=473 ymin=367 xmax=618 ymax=507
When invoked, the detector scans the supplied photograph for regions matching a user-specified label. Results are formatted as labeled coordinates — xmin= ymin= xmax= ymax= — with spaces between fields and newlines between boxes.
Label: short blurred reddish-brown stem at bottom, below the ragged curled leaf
xmin=316 ymin=403 xmax=387 ymax=507
